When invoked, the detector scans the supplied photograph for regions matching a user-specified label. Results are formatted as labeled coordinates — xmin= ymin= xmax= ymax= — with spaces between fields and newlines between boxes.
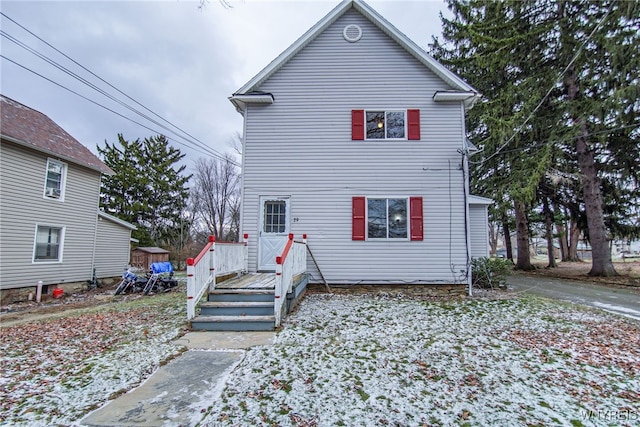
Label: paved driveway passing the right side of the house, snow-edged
xmin=507 ymin=275 xmax=640 ymax=320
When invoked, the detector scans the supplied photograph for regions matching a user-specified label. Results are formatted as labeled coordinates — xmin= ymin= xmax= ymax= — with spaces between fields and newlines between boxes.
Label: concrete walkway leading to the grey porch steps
xmin=80 ymin=332 xmax=275 ymax=427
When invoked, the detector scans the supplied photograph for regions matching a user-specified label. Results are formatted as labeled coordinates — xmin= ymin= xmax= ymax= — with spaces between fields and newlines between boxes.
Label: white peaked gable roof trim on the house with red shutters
xmin=232 ymin=0 xmax=478 ymax=98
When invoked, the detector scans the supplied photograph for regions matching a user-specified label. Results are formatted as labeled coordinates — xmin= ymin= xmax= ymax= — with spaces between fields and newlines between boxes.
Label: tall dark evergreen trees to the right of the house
xmin=430 ymin=0 xmax=640 ymax=276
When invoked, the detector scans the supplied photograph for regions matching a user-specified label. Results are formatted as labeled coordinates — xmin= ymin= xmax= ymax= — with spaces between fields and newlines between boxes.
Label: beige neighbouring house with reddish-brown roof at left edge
xmin=0 ymin=95 xmax=135 ymax=298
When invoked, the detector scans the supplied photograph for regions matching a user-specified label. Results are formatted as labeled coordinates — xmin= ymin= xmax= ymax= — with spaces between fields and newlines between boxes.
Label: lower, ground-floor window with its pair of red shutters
xmin=352 ymin=197 xmax=423 ymax=240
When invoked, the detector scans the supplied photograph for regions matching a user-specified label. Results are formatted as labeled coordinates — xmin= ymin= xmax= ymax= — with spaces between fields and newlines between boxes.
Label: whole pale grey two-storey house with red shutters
xmin=230 ymin=0 xmax=490 ymax=284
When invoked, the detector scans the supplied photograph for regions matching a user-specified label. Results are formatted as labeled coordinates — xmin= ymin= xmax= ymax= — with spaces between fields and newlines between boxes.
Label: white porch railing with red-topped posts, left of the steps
xmin=187 ymin=234 xmax=249 ymax=320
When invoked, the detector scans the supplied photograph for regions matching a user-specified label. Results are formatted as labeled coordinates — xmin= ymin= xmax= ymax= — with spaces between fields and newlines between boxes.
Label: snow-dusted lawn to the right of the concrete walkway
xmin=202 ymin=294 xmax=640 ymax=426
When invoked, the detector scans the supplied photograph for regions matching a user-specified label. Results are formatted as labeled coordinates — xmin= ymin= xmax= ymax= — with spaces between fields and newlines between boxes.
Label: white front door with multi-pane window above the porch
xmin=258 ymin=196 xmax=289 ymax=271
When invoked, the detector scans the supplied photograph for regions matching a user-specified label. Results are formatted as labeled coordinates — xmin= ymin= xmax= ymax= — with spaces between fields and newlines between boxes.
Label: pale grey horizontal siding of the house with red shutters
xmin=242 ymin=10 xmax=466 ymax=283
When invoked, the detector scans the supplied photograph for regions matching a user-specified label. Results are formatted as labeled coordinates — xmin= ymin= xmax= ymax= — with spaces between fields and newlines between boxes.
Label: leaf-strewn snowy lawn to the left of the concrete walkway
xmin=0 ymin=292 xmax=186 ymax=427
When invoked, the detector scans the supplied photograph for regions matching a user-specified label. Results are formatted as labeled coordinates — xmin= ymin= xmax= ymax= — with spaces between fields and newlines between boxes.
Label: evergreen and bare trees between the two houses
xmin=98 ymin=134 xmax=240 ymax=268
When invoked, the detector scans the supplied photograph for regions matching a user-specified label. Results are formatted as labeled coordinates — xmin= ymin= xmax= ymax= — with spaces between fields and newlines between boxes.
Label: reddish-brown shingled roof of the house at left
xmin=0 ymin=95 xmax=113 ymax=175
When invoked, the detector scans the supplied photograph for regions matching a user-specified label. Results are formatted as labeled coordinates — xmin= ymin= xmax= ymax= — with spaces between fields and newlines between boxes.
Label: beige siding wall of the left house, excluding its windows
xmin=0 ymin=140 xmax=100 ymax=289
